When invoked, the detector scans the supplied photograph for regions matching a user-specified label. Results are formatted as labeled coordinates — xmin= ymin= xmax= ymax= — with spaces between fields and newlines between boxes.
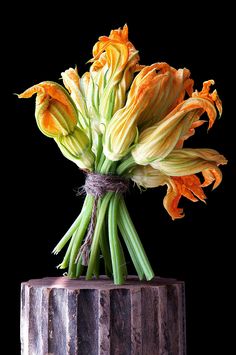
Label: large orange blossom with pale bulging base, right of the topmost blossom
xmin=104 ymin=63 xmax=192 ymax=160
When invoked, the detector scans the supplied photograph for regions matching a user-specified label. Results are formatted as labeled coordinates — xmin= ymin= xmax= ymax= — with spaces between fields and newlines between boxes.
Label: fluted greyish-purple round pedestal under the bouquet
xmin=21 ymin=276 xmax=186 ymax=355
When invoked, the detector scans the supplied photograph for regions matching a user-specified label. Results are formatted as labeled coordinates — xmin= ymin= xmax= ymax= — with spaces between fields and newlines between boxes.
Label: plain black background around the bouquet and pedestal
xmin=1 ymin=2 xmax=236 ymax=355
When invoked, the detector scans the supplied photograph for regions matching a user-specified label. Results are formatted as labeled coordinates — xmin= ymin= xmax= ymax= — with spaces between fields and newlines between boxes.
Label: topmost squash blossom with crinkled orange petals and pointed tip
xmin=87 ymin=25 xmax=139 ymax=128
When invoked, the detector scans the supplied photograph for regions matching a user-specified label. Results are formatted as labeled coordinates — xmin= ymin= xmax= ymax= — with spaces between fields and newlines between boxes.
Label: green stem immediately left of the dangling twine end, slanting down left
xmin=68 ymin=195 xmax=94 ymax=278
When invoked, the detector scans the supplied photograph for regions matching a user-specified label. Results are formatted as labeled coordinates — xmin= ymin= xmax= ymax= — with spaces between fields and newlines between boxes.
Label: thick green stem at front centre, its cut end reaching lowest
xmin=108 ymin=195 xmax=124 ymax=285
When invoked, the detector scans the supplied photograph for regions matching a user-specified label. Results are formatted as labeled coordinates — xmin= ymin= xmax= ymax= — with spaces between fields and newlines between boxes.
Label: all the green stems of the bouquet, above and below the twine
xmin=53 ymin=153 xmax=154 ymax=285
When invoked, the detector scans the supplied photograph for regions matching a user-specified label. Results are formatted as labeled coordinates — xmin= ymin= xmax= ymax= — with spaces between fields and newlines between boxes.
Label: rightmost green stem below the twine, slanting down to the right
xmin=120 ymin=197 xmax=155 ymax=280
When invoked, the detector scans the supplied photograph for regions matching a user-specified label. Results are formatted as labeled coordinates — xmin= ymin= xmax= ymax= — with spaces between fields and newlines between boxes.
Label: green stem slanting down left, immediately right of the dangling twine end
xmin=86 ymin=192 xmax=112 ymax=280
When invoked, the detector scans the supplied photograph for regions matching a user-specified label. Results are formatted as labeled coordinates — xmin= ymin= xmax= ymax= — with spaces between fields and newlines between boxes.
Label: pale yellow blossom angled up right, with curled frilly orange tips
xmin=132 ymin=81 xmax=221 ymax=165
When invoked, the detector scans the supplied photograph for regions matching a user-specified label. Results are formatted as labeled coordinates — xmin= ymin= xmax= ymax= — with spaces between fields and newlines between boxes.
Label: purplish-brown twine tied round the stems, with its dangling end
xmin=75 ymin=173 xmax=129 ymax=266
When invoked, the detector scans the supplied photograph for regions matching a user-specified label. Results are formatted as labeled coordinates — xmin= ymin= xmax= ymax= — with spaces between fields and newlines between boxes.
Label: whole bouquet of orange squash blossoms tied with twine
xmin=18 ymin=25 xmax=227 ymax=284
